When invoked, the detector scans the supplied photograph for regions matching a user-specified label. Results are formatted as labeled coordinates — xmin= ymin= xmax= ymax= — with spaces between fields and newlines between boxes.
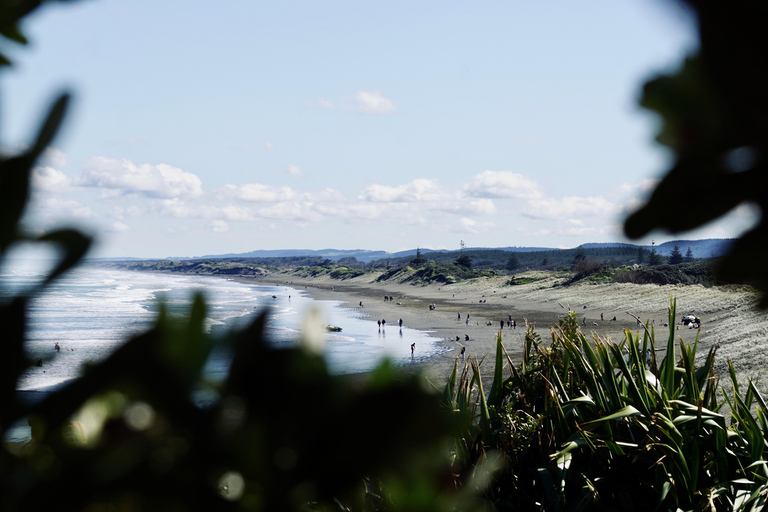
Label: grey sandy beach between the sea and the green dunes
xmin=248 ymin=271 xmax=768 ymax=392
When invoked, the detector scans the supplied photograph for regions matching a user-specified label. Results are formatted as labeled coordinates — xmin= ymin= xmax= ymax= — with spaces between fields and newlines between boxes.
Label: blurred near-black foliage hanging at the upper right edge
xmin=624 ymin=0 xmax=768 ymax=307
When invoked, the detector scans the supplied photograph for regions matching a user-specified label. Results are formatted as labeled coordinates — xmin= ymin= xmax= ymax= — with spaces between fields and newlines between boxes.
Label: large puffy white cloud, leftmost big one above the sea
xmin=75 ymin=156 xmax=203 ymax=199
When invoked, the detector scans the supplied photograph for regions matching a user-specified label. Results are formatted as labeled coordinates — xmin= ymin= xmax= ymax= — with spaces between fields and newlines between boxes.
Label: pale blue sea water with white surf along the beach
xmin=0 ymin=262 xmax=446 ymax=437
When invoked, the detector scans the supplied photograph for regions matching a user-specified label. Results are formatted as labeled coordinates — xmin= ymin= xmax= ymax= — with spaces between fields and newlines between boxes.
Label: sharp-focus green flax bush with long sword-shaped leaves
xmin=444 ymin=301 xmax=768 ymax=510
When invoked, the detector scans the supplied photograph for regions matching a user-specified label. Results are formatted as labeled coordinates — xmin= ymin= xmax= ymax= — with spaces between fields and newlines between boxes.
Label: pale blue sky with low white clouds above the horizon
xmin=0 ymin=0 xmax=754 ymax=258
